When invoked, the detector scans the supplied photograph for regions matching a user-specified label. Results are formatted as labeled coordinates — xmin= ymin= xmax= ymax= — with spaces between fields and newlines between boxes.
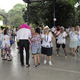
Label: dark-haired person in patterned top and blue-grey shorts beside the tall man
xmin=31 ymin=28 xmax=41 ymax=67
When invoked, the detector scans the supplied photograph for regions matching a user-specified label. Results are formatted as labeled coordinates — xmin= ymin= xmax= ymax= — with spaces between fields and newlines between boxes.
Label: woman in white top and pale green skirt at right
xmin=69 ymin=27 xmax=78 ymax=56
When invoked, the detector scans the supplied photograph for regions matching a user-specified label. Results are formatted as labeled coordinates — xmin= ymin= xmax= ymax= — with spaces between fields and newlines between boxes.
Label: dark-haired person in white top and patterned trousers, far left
xmin=2 ymin=30 xmax=12 ymax=61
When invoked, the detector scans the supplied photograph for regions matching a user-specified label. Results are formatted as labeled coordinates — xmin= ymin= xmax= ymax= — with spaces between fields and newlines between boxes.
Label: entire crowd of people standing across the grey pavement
xmin=0 ymin=23 xmax=80 ymax=68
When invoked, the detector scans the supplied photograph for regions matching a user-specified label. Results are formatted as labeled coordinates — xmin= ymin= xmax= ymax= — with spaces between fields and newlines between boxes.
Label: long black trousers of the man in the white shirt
xmin=19 ymin=40 xmax=29 ymax=65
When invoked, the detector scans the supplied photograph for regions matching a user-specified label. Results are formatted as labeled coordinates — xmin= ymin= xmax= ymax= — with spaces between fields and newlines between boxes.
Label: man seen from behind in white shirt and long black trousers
xmin=17 ymin=24 xmax=31 ymax=68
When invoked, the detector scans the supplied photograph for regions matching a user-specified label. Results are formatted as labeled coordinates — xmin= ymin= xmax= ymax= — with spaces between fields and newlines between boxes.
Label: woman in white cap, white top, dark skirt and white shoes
xmin=42 ymin=26 xmax=54 ymax=65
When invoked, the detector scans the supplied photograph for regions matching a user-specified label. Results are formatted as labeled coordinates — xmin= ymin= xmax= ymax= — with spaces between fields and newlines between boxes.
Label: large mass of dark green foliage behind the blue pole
xmin=23 ymin=0 xmax=75 ymax=27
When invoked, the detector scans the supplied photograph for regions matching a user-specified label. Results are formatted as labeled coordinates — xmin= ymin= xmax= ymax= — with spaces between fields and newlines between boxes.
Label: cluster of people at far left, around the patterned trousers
xmin=0 ymin=26 xmax=14 ymax=61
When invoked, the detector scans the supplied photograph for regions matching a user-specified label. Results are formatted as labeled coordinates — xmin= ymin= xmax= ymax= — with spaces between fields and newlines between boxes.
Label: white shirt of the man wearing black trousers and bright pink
xmin=17 ymin=28 xmax=31 ymax=40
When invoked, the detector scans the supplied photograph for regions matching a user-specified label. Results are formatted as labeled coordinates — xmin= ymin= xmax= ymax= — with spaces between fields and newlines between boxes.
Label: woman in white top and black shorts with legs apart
xmin=57 ymin=27 xmax=67 ymax=57
